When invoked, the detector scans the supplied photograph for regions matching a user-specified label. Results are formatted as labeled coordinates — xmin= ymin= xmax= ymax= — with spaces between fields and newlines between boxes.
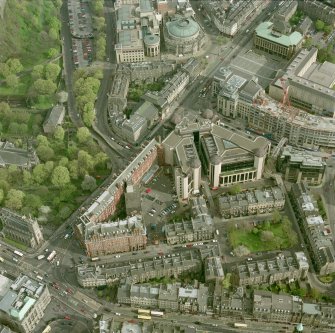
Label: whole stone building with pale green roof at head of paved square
xmin=253 ymin=22 xmax=304 ymax=59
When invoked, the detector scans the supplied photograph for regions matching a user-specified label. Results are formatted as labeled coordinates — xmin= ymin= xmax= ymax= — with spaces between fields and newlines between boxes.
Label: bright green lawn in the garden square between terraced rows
xmin=229 ymin=223 xmax=293 ymax=252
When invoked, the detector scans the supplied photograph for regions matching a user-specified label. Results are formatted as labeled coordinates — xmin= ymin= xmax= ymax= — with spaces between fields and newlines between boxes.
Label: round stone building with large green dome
xmin=164 ymin=16 xmax=205 ymax=55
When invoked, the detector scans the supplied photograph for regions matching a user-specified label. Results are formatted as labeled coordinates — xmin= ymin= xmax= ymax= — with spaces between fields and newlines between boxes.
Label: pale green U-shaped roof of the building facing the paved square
xmin=255 ymin=21 xmax=303 ymax=46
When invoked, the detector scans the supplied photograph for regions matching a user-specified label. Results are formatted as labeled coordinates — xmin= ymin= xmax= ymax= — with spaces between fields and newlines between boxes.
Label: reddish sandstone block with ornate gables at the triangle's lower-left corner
xmin=77 ymin=215 xmax=147 ymax=257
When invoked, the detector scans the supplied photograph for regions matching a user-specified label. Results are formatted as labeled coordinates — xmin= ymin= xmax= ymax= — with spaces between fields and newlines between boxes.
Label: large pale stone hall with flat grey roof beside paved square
xmin=269 ymin=47 xmax=335 ymax=117
